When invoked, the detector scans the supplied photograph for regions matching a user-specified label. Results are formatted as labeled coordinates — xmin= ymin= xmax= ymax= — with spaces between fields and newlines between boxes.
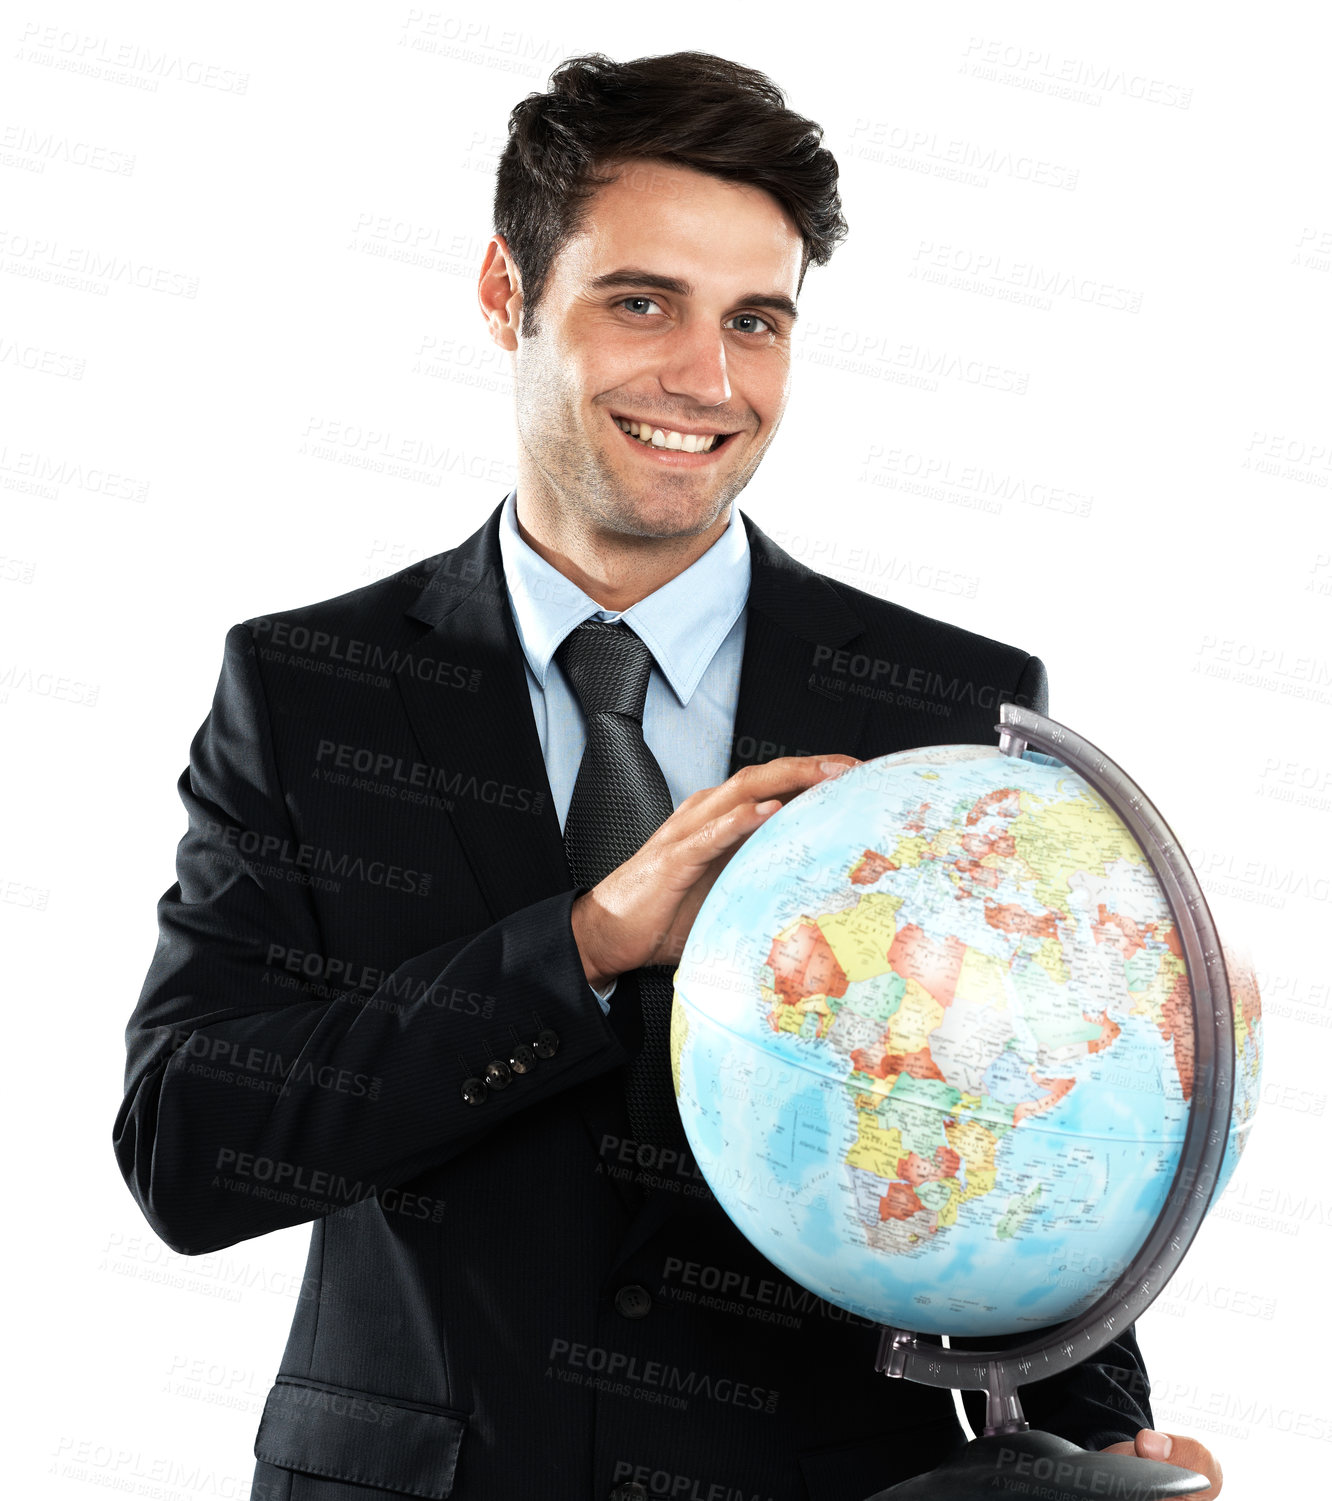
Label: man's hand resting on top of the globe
xmin=572 ymin=755 xmax=860 ymax=989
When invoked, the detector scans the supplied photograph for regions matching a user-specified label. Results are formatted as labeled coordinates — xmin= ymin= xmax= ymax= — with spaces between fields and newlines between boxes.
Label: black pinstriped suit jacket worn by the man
xmin=114 ymin=506 xmax=1150 ymax=1501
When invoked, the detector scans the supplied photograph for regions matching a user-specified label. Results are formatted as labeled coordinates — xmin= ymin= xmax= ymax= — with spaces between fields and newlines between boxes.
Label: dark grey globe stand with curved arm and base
xmin=868 ymin=702 xmax=1236 ymax=1501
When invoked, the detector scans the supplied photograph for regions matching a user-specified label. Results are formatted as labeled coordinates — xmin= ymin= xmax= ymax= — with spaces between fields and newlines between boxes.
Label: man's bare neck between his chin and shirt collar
xmin=515 ymin=491 xmax=731 ymax=611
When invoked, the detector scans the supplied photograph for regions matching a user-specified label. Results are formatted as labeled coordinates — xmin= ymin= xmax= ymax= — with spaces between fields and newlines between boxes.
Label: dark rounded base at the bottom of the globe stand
xmin=868 ymin=1429 xmax=1210 ymax=1501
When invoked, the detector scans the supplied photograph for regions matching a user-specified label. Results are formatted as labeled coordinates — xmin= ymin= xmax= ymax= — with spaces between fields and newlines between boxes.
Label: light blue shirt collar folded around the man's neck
xmin=500 ymin=489 xmax=749 ymax=704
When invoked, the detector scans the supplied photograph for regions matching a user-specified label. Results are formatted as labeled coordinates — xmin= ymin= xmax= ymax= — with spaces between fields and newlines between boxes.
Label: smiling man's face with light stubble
xmin=498 ymin=161 xmax=803 ymax=537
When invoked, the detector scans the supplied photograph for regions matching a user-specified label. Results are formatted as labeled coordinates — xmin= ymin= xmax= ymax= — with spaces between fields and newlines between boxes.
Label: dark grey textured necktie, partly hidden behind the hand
xmin=556 ymin=620 xmax=685 ymax=1147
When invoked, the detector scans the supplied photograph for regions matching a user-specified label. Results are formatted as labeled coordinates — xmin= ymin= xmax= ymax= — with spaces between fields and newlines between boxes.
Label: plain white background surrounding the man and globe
xmin=0 ymin=0 xmax=1332 ymax=1498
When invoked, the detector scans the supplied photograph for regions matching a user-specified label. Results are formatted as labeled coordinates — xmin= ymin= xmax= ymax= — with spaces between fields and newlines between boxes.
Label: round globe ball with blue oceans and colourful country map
xmin=671 ymin=744 xmax=1261 ymax=1336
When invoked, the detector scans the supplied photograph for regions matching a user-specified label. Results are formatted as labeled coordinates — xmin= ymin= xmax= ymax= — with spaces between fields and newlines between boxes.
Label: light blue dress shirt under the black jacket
xmin=500 ymin=489 xmax=749 ymax=1012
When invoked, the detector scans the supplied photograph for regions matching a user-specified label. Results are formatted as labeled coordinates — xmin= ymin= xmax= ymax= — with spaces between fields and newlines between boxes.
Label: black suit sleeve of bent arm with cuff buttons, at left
xmin=113 ymin=626 xmax=641 ymax=1255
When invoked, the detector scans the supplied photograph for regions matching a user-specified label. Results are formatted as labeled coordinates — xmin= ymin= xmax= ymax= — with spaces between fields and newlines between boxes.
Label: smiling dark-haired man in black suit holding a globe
xmin=116 ymin=53 xmax=1210 ymax=1501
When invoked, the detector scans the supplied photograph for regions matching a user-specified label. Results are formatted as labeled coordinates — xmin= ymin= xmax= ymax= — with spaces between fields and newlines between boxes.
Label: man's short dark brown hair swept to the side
xmin=494 ymin=53 xmax=847 ymax=336
